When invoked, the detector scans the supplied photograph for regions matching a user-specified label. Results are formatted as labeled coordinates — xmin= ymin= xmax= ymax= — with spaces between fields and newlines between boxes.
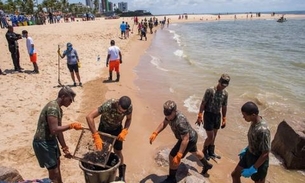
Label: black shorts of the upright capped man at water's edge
xmin=203 ymin=111 xmax=221 ymax=131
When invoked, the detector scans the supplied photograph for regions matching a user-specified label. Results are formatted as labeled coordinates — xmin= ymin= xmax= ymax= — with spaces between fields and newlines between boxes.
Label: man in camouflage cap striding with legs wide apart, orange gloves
xmin=149 ymin=100 xmax=213 ymax=183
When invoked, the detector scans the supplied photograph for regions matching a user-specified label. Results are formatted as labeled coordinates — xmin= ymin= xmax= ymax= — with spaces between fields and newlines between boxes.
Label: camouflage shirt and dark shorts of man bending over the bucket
xmin=98 ymin=99 xmax=132 ymax=150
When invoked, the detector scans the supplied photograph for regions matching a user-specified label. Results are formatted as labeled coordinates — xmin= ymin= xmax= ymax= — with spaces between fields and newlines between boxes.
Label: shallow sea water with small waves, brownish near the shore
xmin=135 ymin=19 xmax=305 ymax=182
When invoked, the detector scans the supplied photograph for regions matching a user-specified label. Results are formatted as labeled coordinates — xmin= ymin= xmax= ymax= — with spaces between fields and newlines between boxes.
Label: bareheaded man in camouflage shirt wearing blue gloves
xmin=231 ymin=101 xmax=271 ymax=183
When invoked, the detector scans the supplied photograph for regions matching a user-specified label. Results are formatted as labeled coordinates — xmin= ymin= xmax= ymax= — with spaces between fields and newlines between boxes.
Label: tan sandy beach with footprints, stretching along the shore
xmin=0 ymin=14 xmax=304 ymax=183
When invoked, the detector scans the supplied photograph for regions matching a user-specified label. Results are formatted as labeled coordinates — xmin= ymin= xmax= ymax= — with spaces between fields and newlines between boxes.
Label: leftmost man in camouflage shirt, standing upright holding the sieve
xmin=33 ymin=86 xmax=83 ymax=183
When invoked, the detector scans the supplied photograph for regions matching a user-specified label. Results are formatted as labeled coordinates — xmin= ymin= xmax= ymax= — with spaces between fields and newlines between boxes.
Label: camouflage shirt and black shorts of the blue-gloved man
xmin=238 ymin=119 xmax=271 ymax=181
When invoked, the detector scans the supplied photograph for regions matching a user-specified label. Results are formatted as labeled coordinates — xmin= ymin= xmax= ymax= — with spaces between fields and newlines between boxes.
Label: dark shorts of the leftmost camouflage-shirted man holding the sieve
xmin=33 ymin=140 xmax=61 ymax=169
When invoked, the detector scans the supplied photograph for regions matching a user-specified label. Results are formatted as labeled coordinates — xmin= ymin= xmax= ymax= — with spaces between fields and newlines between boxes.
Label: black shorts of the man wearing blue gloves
xmin=238 ymin=150 xmax=269 ymax=181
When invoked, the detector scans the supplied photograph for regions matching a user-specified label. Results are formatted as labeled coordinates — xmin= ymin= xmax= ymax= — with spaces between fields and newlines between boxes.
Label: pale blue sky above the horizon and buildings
xmin=69 ymin=0 xmax=305 ymax=15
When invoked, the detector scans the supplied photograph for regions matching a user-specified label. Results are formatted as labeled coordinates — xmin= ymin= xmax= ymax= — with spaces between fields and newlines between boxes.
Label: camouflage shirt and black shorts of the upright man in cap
xmin=202 ymin=87 xmax=228 ymax=131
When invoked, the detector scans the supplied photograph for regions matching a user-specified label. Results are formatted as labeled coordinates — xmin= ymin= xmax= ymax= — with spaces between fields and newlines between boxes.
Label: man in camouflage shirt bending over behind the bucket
xmin=86 ymin=96 xmax=133 ymax=182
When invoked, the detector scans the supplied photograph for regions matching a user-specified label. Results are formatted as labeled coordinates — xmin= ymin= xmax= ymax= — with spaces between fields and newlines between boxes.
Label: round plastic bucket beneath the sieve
xmin=79 ymin=153 xmax=121 ymax=183
